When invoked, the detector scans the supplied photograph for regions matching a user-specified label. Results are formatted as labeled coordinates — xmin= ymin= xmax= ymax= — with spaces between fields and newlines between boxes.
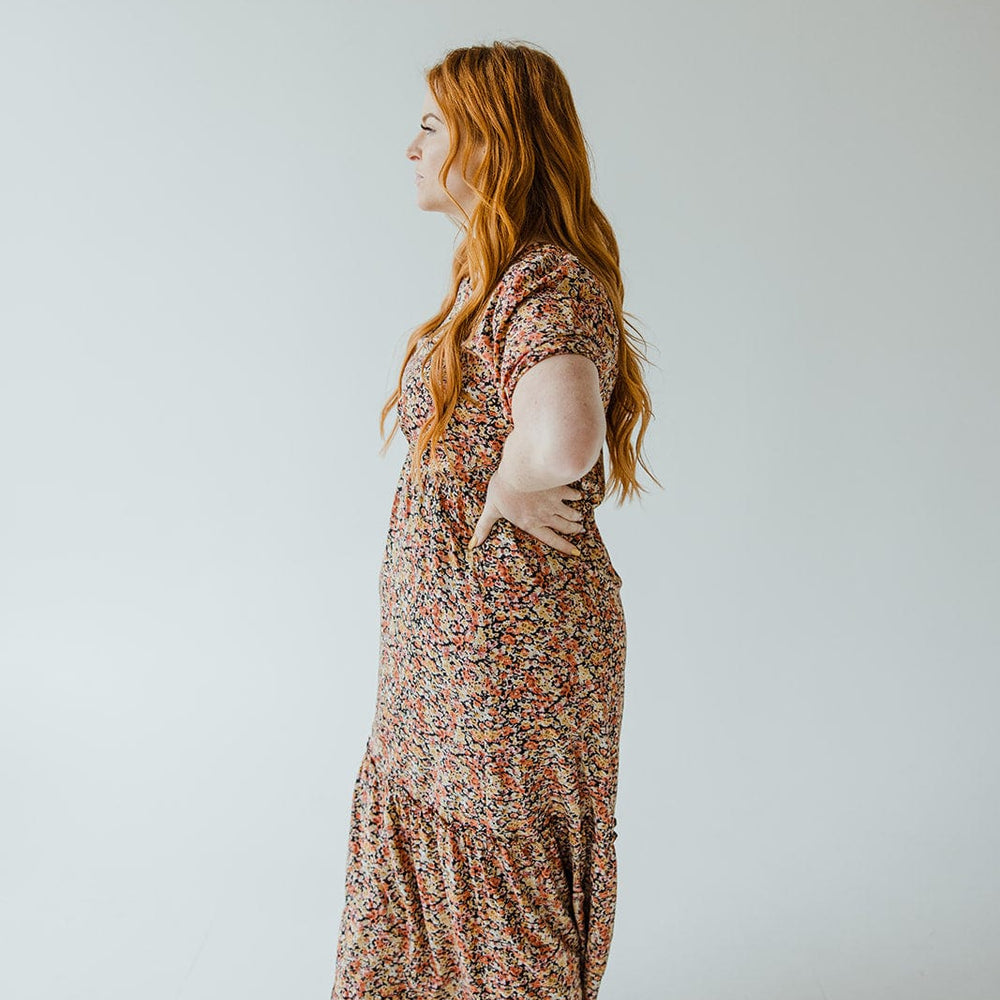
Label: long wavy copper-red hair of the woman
xmin=379 ymin=41 xmax=659 ymax=504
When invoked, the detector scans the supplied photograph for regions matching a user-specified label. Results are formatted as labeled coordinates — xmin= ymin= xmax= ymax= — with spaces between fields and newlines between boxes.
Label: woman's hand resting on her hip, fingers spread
xmin=469 ymin=468 xmax=583 ymax=556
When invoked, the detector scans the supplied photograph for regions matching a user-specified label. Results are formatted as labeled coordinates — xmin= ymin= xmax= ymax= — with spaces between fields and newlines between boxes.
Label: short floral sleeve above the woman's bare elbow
xmin=493 ymin=254 xmax=618 ymax=419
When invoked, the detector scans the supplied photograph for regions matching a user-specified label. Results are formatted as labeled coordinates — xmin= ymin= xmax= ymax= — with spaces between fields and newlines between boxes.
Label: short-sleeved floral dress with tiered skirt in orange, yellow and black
xmin=331 ymin=243 xmax=625 ymax=1000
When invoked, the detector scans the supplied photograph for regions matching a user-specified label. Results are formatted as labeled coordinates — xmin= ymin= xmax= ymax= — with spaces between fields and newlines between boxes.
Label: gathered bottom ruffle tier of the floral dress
xmin=331 ymin=747 xmax=617 ymax=1000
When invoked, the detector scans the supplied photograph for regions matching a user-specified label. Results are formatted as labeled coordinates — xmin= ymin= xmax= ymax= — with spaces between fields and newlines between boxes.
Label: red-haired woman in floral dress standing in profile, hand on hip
xmin=332 ymin=42 xmax=651 ymax=1000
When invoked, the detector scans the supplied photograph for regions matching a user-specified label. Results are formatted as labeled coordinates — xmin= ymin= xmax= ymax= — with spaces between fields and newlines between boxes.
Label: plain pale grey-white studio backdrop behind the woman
xmin=0 ymin=0 xmax=1000 ymax=1000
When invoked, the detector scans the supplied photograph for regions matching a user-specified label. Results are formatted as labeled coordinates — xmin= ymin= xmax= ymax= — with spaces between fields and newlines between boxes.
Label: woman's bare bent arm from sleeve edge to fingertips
xmin=469 ymin=354 xmax=606 ymax=555
